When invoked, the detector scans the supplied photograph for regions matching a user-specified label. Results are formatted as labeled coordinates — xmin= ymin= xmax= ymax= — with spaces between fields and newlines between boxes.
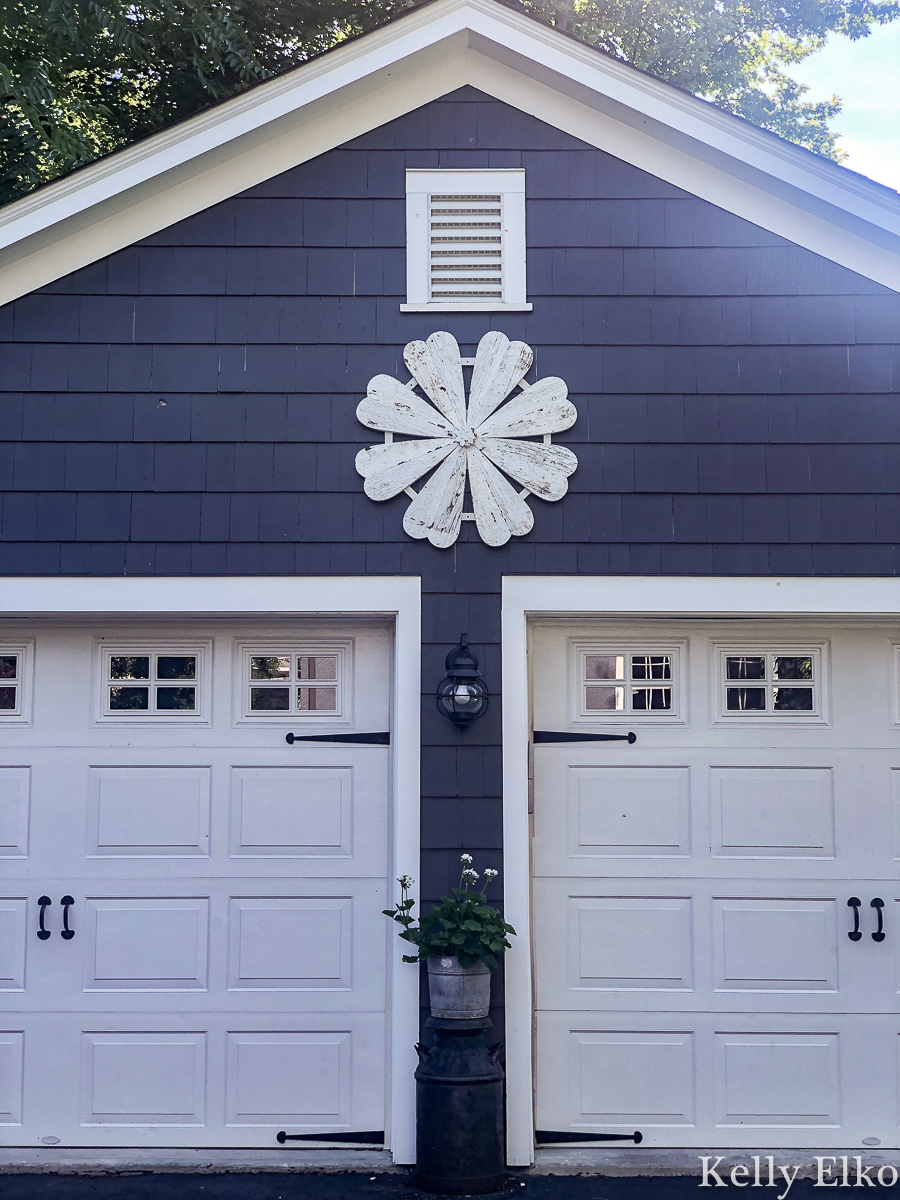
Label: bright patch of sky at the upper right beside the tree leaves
xmin=788 ymin=20 xmax=900 ymax=191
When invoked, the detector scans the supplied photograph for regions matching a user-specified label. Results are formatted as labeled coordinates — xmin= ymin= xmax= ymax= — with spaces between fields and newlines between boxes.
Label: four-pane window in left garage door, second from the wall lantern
xmin=97 ymin=640 xmax=210 ymax=725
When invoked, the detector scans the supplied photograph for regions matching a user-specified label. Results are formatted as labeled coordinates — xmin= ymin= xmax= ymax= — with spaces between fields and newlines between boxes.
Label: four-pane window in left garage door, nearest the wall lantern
xmin=238 ymin=638 xmax=350 ymax=725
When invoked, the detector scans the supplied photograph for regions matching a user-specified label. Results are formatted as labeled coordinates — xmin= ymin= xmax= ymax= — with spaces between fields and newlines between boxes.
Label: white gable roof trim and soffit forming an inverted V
xmin=0 ymin=0 xmax=900 ymax=304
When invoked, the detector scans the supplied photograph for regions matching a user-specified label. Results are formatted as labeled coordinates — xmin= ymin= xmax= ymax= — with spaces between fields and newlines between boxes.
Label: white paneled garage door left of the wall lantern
xmin=0 ymin=622 xmax=391 ymax=1146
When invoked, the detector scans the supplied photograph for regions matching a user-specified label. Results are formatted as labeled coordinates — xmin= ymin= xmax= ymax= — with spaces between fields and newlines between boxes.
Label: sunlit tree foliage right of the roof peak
xmin=523 ymin=0 xmax=900 ymax=162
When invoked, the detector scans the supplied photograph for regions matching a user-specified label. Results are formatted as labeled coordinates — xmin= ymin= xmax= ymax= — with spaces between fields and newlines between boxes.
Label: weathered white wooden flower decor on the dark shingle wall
xmin=356 ymin=331 xmax=578 ymax=548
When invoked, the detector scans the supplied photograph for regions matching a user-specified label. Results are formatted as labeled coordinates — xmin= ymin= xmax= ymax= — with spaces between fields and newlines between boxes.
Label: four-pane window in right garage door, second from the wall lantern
xmin=715 ymin=643 xmax=824 ymax=724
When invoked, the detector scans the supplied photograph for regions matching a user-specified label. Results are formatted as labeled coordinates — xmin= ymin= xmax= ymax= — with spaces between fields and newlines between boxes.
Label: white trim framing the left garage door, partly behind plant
xmin=0 ymin=575 xmax=421 ymax=1163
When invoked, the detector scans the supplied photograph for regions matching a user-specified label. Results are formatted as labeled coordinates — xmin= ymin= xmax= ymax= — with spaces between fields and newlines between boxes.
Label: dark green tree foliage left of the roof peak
xmin=0 ymin=0 xmax=407 ymax=203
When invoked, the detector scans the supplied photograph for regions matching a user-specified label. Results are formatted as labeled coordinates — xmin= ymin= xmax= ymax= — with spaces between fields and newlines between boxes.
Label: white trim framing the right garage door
xmin=502 ymin=575 xmax=900 ymax=1166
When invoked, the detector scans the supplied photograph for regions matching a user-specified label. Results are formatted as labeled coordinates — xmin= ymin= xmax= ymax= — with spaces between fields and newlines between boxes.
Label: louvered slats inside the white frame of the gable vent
xmin=428 ymin=194 xmax=503 ymax=304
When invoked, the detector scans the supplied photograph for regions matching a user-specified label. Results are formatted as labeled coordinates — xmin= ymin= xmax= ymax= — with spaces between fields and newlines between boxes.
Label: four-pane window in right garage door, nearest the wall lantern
xmin=574 ymin=638 xmax=684 ymax=724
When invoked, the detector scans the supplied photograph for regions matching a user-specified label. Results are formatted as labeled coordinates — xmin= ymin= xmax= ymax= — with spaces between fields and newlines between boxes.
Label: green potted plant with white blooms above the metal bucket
xmin=383 ymin=854 xmax=516 ymax=971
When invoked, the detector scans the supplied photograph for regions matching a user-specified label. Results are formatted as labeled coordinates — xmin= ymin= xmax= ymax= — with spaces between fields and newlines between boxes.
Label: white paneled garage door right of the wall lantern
xmin=533 ymin=620 xmax=900 ymax=1147
